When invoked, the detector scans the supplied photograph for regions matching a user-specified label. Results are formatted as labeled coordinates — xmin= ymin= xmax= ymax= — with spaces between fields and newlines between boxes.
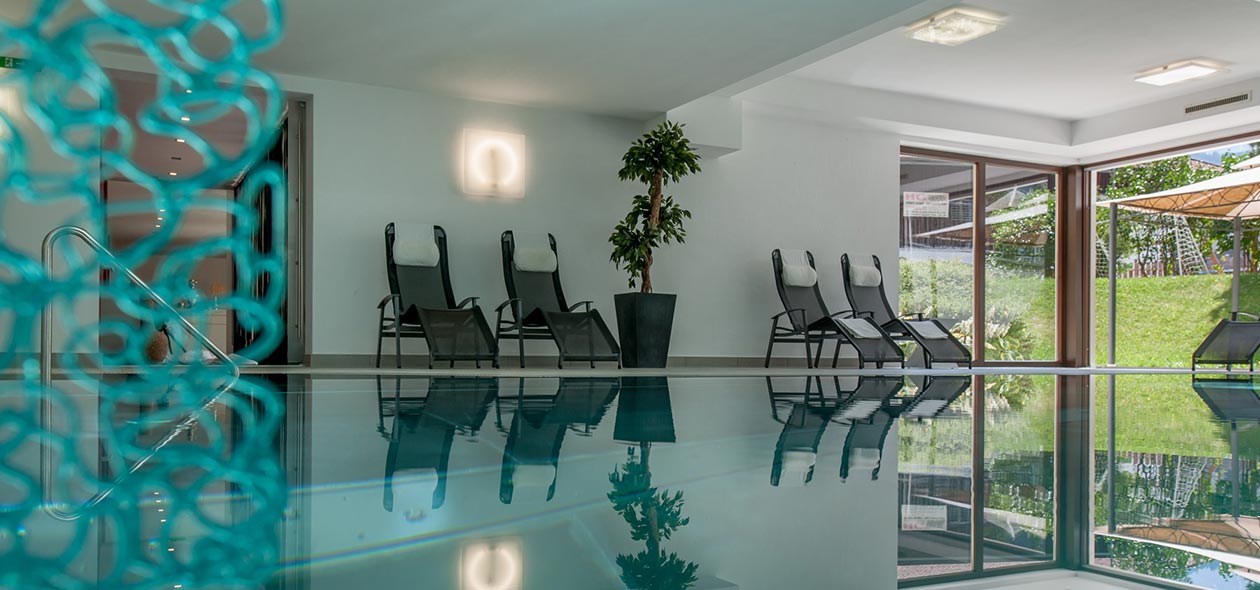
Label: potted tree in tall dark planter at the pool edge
xmin=609 ymin=121 xmax=701 ymax=368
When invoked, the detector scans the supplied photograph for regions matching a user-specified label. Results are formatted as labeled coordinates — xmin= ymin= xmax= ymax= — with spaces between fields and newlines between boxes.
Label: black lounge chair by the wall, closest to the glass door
xmin=840 ymin=255 xmax=971 ymax=368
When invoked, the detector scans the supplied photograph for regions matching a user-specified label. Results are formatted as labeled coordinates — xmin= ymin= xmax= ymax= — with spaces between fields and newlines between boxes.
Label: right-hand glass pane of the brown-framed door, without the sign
xmin=984 ymin=164 xmax=1058 ymax=362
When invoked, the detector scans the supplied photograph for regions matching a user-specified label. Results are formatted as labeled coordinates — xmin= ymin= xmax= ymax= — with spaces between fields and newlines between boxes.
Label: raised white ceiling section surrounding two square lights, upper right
xmin=795 ymin=0 xmax=1260 ymax=121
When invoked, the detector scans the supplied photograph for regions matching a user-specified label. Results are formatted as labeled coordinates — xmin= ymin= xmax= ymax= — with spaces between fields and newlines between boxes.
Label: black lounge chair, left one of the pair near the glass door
xmin=765 ymin=250 xmax=906 ymax=368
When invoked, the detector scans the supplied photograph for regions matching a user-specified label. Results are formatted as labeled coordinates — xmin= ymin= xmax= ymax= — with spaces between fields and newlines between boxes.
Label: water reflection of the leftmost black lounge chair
xmin=377 ymin=377 xmax=499 ymax=512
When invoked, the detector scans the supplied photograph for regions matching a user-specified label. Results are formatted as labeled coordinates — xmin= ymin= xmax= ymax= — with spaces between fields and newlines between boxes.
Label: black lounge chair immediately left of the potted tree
xmin=495 ymin=231 xmax=621 ymax=368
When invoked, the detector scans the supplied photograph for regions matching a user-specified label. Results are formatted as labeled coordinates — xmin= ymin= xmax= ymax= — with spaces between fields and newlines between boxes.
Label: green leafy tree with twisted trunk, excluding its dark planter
xmin=609 ymin=121 xmax=701 ymax=292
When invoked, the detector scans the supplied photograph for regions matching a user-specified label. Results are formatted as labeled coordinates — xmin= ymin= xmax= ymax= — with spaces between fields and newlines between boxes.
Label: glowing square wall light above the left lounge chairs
xmin=464 ymin=129 xmax=525 ymax=198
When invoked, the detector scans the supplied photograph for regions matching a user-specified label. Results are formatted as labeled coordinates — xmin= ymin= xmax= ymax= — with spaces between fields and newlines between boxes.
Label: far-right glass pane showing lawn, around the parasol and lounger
xmin=1092 ymin=142 xmax=1260 ymax=367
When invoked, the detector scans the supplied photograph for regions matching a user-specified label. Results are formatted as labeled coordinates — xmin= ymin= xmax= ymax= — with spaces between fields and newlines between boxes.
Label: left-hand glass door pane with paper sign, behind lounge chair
xmin=890 ymin=155 xmax=975 ymax=347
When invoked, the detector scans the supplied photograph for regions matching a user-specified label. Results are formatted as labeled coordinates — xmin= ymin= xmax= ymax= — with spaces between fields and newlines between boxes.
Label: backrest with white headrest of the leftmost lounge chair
xmin=386 ymin=223 xmax=455 ymax=324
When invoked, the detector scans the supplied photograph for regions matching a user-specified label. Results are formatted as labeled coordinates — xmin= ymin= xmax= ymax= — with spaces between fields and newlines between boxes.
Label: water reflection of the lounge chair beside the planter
xmin=499 ymin=377 xmax=620 ymax=504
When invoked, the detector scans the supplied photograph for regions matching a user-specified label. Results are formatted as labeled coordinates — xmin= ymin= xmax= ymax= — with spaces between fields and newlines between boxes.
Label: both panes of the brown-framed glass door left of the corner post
xmin=898 ymin=153 xmax=1060 ymax=363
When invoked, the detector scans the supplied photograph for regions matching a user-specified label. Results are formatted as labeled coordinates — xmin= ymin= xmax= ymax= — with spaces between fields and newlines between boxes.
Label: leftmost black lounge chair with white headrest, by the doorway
xmin=377 ymin=223 xmax=499 ymax=368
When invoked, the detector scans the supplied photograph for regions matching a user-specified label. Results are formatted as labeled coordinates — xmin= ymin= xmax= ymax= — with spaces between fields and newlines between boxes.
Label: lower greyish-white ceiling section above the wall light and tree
xmin=253 ymin=0 xmax=937 ymax=117
